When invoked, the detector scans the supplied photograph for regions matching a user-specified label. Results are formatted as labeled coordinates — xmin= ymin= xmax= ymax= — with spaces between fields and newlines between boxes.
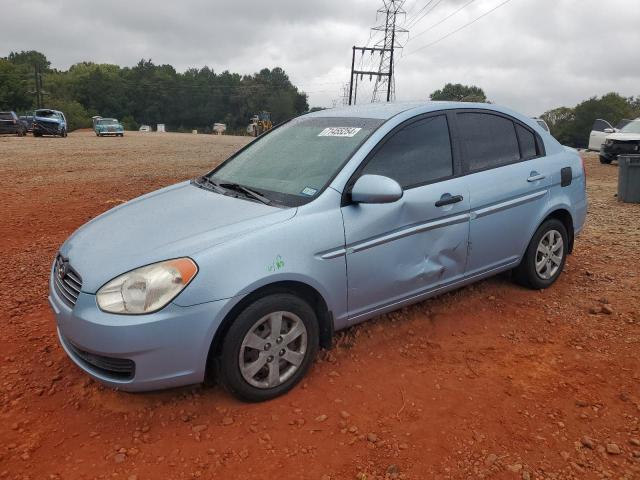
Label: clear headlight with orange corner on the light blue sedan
xmin=96 ymin=258 xmax=198 ymax=315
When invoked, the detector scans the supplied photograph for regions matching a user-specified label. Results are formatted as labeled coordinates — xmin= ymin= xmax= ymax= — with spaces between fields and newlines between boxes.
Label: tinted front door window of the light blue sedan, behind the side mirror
xmin=362 ymin=115 xmax=453 ymax=188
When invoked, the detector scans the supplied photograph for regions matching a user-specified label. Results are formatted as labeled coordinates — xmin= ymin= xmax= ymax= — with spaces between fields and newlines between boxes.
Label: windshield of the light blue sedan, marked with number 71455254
xmin=210 ymin=117 xmax=383 ymax=206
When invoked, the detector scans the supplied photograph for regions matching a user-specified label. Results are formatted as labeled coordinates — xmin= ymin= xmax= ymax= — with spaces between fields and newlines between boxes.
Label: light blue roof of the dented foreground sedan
xmin=307 ymin=101 xmax=523 ymax=120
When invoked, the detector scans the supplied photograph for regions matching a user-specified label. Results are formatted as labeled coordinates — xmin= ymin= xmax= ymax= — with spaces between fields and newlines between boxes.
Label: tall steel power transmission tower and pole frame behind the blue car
xmin=349 ymin=0 xmax=408 ymax=105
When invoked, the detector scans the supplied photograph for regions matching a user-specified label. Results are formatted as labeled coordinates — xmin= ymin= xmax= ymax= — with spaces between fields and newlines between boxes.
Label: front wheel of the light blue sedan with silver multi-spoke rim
xmin=217 ymin=293 xmax=319 ymax=402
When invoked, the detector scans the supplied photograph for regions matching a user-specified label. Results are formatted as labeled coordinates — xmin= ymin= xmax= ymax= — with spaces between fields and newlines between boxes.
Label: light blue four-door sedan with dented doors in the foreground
xmin=49 ymin=102 xmax=587 ymax=401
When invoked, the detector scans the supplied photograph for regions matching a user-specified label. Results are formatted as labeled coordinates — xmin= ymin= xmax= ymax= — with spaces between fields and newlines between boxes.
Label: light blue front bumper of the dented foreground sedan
xmin=49 ymin=268 xmax=231 ymax=392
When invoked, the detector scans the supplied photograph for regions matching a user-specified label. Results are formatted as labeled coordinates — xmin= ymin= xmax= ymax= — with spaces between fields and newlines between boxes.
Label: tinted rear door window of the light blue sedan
xmin=457 ymin=112 xmax=520 ymax=172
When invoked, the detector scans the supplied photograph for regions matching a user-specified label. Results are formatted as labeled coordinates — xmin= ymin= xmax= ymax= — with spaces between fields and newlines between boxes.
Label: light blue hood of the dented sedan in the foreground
xmin=60 ymin=182 xmax=296 ymax=293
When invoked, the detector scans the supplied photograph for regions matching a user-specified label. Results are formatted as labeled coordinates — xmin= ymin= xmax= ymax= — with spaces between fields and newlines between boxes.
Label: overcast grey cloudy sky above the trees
xmin=0 ymin=0 xmax=640 ymax=116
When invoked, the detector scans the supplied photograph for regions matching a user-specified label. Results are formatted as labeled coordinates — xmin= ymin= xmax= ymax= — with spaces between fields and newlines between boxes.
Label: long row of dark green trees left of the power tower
xmin=0 ymin=51 xmax=309 ymax=132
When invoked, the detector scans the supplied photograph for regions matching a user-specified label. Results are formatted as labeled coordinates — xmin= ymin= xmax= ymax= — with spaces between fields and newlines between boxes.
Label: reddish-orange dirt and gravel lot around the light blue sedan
xmin=0 ymin=133 xmax=640 ymax=480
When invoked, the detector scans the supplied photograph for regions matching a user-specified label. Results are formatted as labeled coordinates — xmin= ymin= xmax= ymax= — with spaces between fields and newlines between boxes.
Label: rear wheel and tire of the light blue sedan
xmin=515 ymin=218 xmax=569 ymax=290
